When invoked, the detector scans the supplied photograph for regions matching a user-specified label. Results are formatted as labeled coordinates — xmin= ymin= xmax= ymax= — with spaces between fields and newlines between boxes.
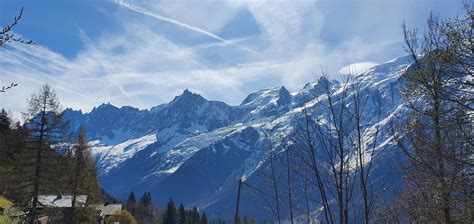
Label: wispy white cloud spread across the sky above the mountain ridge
xmin=0 ymin=0 xmax=464 ymax=119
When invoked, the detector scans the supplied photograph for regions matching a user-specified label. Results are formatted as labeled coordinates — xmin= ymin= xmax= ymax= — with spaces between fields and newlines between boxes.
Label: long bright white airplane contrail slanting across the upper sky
xmin=115 ymin=0 xmax=260 ymax=55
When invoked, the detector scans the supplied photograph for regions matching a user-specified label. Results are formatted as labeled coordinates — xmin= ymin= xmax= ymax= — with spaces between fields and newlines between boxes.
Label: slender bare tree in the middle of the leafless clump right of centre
xmin=309 ymin=75 xmax=355 ymax=224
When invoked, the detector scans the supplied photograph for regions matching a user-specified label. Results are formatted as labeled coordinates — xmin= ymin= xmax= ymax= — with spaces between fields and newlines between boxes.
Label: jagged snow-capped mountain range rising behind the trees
xmin=65 ymin=54 xmax=410 ymax=218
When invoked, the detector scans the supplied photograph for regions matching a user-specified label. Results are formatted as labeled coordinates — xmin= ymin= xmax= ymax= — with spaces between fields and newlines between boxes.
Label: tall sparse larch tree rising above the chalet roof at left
xmin=16 ymin=84 xmax=66 ymax=224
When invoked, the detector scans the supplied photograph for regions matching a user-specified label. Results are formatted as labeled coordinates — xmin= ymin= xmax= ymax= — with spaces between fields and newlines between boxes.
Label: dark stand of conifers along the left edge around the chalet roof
xmin=0 ymin=85 xmax=102 ymax=223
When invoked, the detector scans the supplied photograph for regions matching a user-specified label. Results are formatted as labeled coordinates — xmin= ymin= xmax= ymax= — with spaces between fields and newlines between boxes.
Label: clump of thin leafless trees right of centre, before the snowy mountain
xmin=295 ymin=74 xmax=381 ymax=223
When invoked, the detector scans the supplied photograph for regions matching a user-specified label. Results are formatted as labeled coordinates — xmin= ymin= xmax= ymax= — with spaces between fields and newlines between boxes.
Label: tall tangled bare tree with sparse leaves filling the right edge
xmin=395 ymin=7 xmax=474 ymax=223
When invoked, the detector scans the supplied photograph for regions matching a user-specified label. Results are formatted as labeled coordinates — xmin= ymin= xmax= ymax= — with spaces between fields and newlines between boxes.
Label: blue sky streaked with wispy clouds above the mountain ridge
xmin=0 ymin=0 xmax=464 ymax=118
